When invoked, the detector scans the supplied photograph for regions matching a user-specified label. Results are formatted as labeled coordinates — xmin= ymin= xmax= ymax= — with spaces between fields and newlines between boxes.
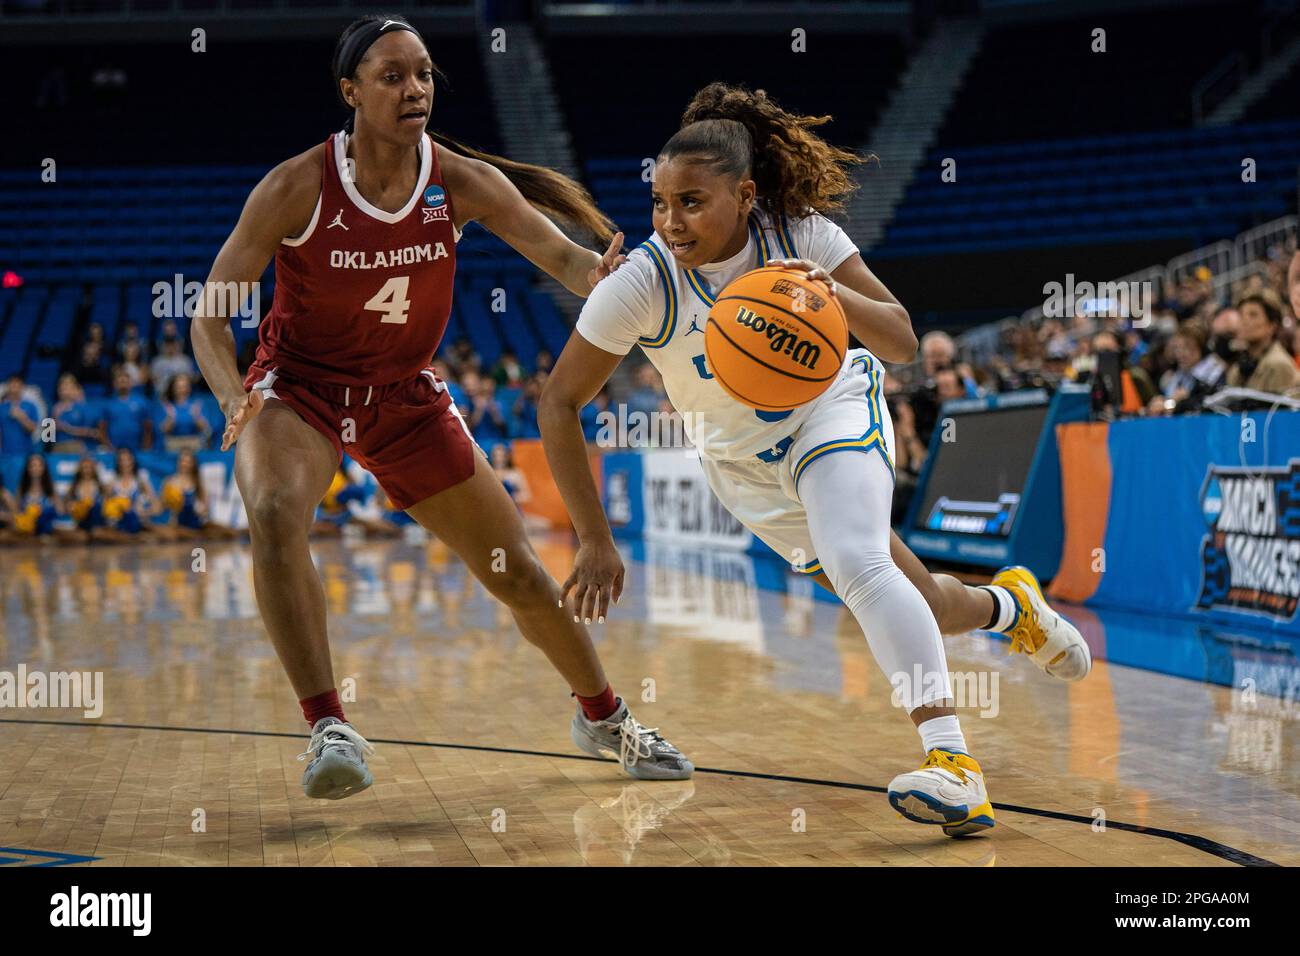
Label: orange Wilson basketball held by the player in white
xmin=705 ymin=267 xmax=849 ymax=411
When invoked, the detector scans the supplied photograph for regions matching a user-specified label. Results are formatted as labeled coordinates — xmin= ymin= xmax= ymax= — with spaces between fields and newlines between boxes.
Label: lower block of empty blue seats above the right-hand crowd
xmin=876 ymin=120 xmax=1300 ymax=256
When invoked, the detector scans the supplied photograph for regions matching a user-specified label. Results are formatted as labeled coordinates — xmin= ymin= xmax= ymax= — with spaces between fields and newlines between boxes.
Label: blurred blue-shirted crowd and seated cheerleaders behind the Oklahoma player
xmin=0 ymin=319 xmax=608 ymax=544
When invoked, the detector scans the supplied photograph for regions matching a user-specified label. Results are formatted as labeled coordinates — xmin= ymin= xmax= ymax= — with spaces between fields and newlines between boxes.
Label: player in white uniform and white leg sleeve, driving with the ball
xmin=538 ymin=83 xmax=1091 ymax=836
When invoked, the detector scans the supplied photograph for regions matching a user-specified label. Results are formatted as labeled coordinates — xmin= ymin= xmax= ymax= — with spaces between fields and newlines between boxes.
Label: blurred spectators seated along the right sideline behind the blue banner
xmin=885 ymin=239 xmax=1300 ymax=523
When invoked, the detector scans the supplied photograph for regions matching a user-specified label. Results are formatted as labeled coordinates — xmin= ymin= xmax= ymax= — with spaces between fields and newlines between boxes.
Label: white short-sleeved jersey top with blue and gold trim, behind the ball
xmin=577 ymin=208 xmax=858 ymax=460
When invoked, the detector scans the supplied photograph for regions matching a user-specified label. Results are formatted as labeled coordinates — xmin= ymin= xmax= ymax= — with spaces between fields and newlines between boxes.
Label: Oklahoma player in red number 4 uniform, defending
xmin=192 ymin=17 xmax=694 ymax=799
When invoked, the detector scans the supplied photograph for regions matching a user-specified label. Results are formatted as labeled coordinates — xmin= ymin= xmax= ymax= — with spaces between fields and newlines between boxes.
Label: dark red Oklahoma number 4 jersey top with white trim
xmin=256 ymin=133 xmax=460 ymax=386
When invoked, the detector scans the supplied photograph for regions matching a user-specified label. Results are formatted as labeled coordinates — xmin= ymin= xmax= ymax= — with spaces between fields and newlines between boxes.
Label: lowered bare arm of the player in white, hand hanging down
xmin=537 ymin=332 xmax=624 ymax=623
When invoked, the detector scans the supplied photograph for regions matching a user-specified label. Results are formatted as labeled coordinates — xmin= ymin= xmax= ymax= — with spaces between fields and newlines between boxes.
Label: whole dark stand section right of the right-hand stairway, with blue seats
xmin=874 ymin=3 xmax=1300 ymax=258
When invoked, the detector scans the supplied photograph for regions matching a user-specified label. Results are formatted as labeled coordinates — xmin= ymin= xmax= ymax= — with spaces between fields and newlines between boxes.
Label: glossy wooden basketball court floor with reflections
xmin=0 ymin=538 xmax=1300 ymax=866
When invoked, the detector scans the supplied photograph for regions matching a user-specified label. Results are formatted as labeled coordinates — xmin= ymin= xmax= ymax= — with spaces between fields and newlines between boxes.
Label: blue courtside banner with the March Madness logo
xmin=1066 ymin=412 xmax=1300 ymax=635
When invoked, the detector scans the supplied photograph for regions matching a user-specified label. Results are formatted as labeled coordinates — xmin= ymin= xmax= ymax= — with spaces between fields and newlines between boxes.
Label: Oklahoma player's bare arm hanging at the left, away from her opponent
xmin=191 ymin=147 xmax=324 ymax=450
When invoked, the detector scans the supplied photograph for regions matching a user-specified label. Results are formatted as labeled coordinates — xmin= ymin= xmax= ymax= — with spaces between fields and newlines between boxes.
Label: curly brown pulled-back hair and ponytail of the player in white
xmin=659 ymin=82 xmax=871 ymax=216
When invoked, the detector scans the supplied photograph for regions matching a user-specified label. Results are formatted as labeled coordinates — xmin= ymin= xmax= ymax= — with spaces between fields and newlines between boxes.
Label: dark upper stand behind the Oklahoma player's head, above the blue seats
xmin=0 ymin=38 xmax=501 ymax=172
